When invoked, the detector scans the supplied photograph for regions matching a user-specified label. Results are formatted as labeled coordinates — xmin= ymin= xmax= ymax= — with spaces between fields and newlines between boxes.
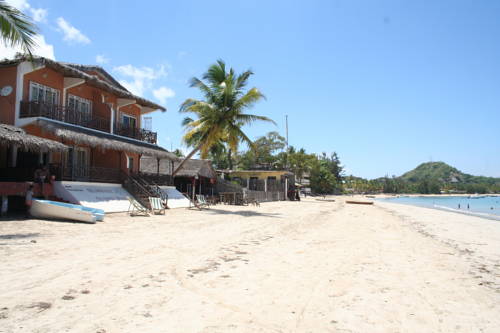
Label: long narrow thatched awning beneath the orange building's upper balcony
xmin=36 ymin=119 xmax=177 ymax=159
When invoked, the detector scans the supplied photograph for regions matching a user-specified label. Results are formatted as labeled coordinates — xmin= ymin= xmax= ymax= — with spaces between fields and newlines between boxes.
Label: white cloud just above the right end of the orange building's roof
xmin=113 ymin=64 xmax=167 ymax=96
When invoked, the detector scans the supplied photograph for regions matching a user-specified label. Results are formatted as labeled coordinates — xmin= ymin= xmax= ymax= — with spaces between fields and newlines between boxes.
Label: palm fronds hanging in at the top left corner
xmin=0 ymin=0 xmax=37 ymax=57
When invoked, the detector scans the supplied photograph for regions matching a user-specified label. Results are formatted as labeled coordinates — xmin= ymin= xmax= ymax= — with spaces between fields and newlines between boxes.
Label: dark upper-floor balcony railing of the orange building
xmin=19 ymin=101 xmax=157 ymax=144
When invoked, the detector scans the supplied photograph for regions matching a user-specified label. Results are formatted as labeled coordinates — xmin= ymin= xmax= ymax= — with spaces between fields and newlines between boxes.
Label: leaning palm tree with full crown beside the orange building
xmin=172 ymin=60 xmax=274 ymax=176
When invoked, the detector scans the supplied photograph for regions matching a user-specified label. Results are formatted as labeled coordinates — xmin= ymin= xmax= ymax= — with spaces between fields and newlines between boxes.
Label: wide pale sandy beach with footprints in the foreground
xmin=0 ymin=197 xmax=500 ymax=333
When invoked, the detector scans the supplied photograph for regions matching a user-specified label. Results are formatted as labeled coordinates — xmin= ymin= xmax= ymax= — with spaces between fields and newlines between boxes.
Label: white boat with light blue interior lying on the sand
xmin=30 ymin=200 xmax=98 ymax=223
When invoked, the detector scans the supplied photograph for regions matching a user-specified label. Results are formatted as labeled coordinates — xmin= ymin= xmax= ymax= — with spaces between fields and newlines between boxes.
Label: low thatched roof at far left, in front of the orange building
xmin=0 ymin=124 xmax=68 ymax=151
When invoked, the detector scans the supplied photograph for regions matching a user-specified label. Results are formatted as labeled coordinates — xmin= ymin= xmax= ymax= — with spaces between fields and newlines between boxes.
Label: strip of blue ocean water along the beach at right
xmin=379 ymin=195 xmax=500 ymax=219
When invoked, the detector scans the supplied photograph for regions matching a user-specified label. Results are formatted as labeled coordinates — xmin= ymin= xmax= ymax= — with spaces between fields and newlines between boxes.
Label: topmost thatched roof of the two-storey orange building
xmin=0 ymin=57 xmax=167 ymax=111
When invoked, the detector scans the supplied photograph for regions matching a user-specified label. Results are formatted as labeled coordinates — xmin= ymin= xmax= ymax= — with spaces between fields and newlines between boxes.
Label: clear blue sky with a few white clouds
xmin=0 ymin=0 xmax=500 ymax=178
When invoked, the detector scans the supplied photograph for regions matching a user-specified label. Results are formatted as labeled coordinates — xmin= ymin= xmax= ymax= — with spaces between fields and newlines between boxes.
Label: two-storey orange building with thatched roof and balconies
xmin=0 ymin=57 xmax=175 ymax=213
